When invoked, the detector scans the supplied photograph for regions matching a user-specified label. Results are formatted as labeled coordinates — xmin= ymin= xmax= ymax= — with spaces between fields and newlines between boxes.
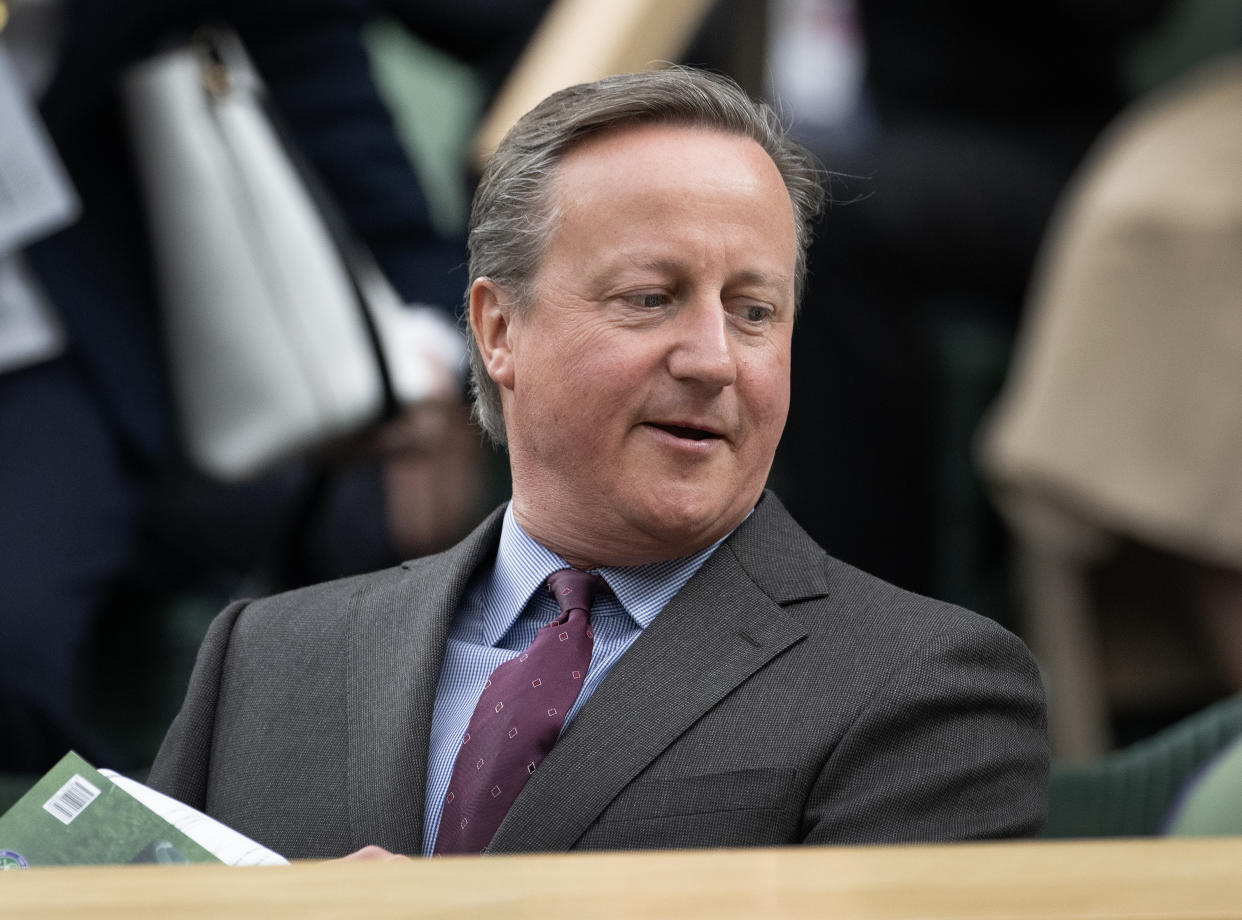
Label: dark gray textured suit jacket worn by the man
xmin=149 ymin=494 xmax=1048 ymax=858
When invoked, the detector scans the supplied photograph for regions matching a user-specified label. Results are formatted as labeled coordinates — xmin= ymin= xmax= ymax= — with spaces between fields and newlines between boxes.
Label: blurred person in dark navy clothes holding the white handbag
xmin=0 ymin=0 xmax=486 ymax=771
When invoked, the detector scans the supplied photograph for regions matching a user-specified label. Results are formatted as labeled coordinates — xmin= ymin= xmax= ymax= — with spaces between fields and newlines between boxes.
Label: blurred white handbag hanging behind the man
xmin=123 ymin=29 xmax=432 ymax=480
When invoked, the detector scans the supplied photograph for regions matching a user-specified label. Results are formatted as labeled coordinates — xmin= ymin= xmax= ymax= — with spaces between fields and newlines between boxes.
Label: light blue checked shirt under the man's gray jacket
xmin=422 ymin=504 xmax=724 ymax=855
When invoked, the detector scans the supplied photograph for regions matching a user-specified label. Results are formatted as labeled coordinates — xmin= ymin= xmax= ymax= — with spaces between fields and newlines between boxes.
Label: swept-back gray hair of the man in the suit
xmin=467 ymin=66 xmax=825 ymax=444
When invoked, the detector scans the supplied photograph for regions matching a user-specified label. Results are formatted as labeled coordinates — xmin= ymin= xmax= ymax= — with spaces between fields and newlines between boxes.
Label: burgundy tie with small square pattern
xmin=435 ymin=569 xmax=611 ymax=854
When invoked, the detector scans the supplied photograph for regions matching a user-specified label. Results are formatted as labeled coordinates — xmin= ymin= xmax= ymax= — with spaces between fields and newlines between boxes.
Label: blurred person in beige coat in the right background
xmin=979 ymin=46 xmax=1242 ymax=757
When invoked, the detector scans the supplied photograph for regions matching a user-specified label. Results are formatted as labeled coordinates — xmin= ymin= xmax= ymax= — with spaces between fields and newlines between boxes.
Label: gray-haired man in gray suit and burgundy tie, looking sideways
xmin=150 ymin=68 xmax=1048 ymax=858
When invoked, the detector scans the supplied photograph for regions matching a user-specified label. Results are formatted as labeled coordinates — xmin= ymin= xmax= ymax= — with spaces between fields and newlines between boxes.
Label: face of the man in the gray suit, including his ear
xmin=472 ymin=125 xmax=796 ymax=567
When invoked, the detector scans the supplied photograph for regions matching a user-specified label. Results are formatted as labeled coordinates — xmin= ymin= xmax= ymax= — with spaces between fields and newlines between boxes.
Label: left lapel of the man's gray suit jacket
xmin=345 ymin=508 xmax=503 ymax=853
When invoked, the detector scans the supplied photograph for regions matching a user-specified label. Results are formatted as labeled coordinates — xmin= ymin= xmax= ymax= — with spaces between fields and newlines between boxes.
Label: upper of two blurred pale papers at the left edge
xmin=0 ymin=45 xmax=79 ymax=256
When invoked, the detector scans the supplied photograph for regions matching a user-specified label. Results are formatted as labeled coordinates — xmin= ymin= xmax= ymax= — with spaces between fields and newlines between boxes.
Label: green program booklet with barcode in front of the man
xmin=0 ymin=751 xmax=286 ymax=870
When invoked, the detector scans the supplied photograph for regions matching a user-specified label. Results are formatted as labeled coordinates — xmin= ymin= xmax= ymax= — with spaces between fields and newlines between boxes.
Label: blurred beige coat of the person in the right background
xmin=981 ymin=56 xmax=1242 ymax=567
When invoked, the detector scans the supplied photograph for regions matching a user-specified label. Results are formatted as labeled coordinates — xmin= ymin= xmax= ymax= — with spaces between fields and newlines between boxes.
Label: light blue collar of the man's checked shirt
xmin=482 ymin=502 xmax=728 ymax=646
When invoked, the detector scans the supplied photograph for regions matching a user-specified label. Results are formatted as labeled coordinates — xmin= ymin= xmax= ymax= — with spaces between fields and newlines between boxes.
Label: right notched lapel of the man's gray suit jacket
xmin=488 ymin=495 xmax=827 ymax=853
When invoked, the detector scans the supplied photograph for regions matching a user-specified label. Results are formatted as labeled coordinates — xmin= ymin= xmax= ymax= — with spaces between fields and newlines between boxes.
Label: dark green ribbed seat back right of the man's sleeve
xmin=1043 ymin=695 xmax=1242 ymax=838
